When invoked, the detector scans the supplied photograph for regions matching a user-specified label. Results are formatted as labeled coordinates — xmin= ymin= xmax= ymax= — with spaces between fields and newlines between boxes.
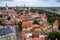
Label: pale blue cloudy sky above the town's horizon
xmin=0 ymin=0 xmax=60 ymax=7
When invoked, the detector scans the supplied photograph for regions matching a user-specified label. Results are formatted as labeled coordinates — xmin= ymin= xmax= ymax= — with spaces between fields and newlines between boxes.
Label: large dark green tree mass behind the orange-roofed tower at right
xmin=46 ymin=11 xmax=60 ymax=25
